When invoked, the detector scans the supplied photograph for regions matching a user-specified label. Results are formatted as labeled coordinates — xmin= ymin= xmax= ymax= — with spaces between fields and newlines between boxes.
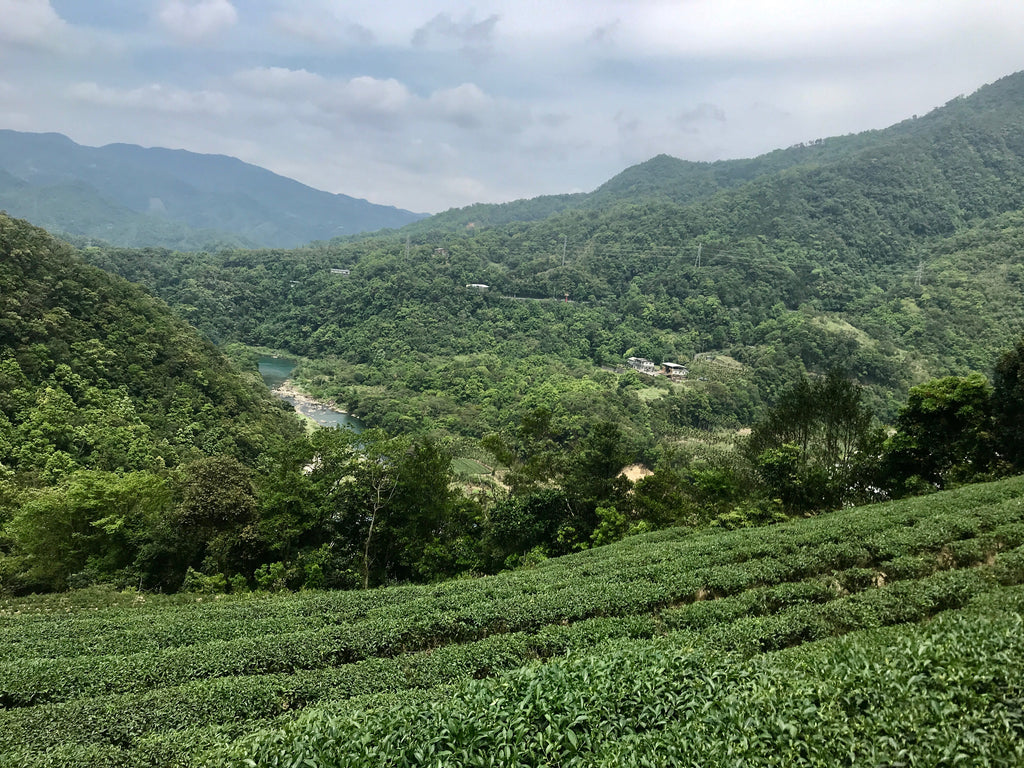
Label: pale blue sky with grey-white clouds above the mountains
xmin=0 ymin=0 xmax=1024 ymax=213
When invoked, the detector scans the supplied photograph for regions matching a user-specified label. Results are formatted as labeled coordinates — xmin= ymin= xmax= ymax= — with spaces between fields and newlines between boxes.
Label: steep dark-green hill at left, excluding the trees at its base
xmin=0 ymin=207 xmax=294 ymax=484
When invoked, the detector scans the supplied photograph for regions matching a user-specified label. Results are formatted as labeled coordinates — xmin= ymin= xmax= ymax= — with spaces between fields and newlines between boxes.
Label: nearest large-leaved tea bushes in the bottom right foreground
xmin=231 ymin=591 xmax=1024 ymax=766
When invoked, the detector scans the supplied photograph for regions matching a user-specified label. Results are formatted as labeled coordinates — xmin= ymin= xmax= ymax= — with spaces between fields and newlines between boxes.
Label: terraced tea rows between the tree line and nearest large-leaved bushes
xmin=0 ymin=478 xmax=1024 ymax=765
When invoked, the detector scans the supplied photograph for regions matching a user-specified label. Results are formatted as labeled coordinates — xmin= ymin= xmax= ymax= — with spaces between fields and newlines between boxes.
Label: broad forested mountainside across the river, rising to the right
xmin=89 ymin=76 xmax=1024 ymax=437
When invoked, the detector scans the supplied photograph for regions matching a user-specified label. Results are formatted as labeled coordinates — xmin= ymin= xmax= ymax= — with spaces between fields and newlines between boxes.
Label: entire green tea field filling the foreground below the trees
xmin=0 ymin=478 xmax=1024 ymax=766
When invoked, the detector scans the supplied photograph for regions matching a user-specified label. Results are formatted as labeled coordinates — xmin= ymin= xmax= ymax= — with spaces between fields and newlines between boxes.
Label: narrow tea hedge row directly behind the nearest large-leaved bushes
xmin=8 ymin=551 xmax=1024 ymax=757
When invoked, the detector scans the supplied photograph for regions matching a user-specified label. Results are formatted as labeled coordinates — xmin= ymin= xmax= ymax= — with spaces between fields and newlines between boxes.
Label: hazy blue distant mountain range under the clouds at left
xmin=0 ymin=130 xmax=425 ymax=249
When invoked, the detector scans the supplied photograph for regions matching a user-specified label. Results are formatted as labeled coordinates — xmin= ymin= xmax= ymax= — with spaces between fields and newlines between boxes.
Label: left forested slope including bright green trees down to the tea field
xmin=0 ymin=215 xmax=298 ymax=589
